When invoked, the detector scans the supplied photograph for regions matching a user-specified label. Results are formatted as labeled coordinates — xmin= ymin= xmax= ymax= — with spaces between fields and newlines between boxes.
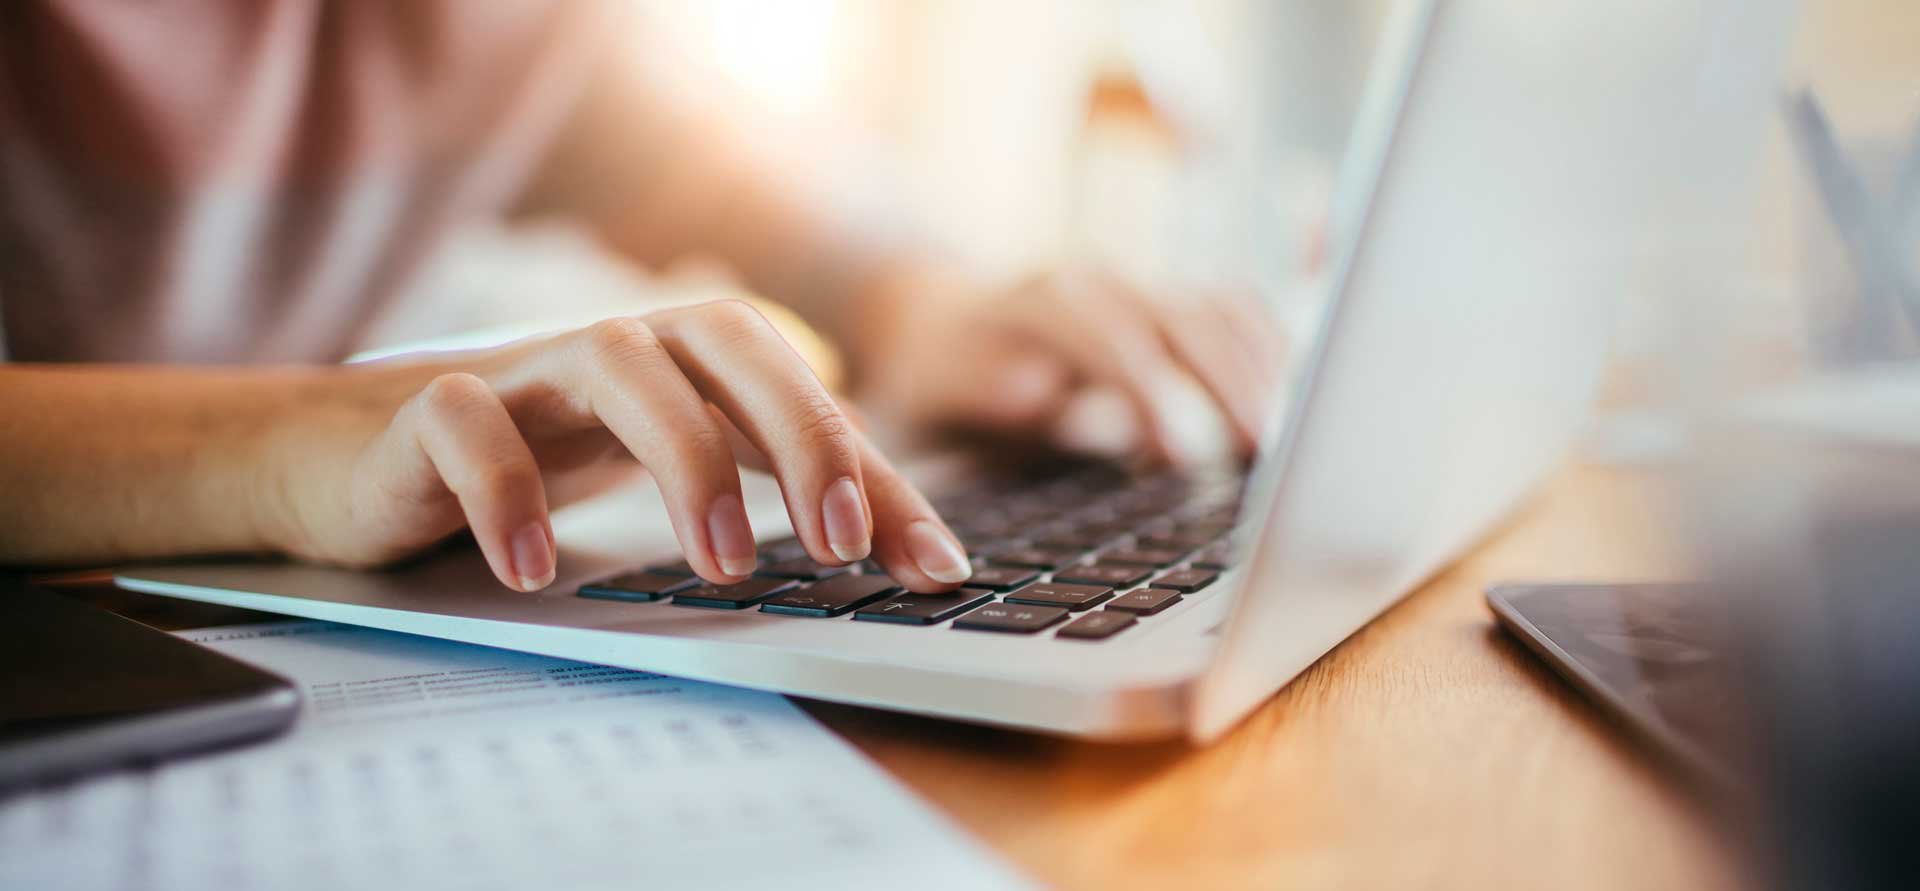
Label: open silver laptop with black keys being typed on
xmin=119 ymin=0 xmax=1770 ymax=741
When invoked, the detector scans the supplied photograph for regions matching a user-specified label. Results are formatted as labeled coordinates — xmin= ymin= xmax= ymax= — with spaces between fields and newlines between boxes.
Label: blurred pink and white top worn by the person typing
xmin=0 ymin=0 xmax=609 ymax=363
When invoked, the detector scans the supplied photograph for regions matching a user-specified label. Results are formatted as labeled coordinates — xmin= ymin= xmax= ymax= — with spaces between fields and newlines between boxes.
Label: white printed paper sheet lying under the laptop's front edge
xmin=0 ymin=622 xmax=1027 ymax=891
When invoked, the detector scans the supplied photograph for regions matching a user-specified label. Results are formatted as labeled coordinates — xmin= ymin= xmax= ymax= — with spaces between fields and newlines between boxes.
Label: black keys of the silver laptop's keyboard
xmin=578 ymin=465 xmax=1246 ymax=641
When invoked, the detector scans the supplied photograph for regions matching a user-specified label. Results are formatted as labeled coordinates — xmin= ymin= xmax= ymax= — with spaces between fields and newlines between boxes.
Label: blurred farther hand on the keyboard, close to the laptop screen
xmin=849 ymin=271 xmax=1284 ymax=463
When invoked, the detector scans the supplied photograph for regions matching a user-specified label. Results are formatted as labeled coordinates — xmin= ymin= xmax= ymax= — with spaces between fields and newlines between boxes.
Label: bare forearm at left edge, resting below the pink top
xmin=0 ymin=365 xmax=349 ymax=565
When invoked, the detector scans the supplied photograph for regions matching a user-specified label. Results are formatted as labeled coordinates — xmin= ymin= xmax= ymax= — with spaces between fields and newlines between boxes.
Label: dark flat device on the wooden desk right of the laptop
xmin=1486 ymin=584 xmax=1751 ymax=793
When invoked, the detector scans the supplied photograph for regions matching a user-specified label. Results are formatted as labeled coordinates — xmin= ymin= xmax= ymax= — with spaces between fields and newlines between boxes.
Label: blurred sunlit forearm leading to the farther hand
xmin=522 ymin=28 xmax=952 ymax=359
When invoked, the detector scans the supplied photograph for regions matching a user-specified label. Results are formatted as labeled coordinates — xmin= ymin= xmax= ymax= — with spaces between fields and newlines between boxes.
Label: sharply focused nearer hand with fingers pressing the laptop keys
xmin=261 ymin=300 xmax=970 ymax=591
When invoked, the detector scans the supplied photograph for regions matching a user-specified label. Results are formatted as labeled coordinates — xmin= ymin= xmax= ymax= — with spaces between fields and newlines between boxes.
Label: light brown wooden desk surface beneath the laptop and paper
xmin=67 ymin=469 xmax=1736 ymax=889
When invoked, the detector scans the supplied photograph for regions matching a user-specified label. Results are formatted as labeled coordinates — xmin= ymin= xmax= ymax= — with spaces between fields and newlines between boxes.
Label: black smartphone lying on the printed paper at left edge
xmin=0 ymin=574 xmax=300 ymax=793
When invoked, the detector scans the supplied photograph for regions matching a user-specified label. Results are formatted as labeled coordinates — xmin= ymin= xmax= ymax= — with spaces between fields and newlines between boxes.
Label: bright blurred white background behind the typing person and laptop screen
xmin=369 ymin=0 xmax=1920 ymax=407
